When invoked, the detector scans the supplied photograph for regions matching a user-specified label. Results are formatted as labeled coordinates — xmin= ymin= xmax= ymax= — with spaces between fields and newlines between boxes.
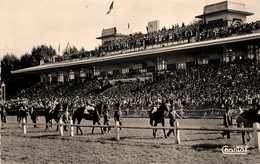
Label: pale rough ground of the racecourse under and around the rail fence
xmin=1 ymin=117 xmax=260 ymax=164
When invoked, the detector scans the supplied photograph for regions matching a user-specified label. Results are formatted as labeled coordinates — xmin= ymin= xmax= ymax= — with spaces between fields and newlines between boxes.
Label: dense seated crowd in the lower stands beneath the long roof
xmin=6 ymin=60 xmax=260 ymax=115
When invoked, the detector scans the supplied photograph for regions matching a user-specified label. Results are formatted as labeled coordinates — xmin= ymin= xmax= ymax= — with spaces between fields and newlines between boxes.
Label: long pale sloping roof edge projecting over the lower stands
xmin=11 ymin=33 xmax=260 ymax=74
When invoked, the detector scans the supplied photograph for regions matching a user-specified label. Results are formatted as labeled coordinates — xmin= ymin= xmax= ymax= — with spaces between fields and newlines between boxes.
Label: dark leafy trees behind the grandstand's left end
xmin=0 ymin=45 xmax=86 ymax=99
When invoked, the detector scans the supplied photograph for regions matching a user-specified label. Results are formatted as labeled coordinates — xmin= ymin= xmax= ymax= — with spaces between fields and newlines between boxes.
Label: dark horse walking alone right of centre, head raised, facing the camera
xmin=149 ymin=102 xmax=169 ymax=138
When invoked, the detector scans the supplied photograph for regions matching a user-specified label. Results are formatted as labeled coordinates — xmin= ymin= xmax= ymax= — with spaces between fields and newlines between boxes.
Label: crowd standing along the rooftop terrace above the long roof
xmin=50 ymin=22 xmax=260 ymax=61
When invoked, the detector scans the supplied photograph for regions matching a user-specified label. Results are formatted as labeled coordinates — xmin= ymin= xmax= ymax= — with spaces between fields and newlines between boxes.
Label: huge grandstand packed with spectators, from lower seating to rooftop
xmin=12 ymin=1 xmax=260 ymax=115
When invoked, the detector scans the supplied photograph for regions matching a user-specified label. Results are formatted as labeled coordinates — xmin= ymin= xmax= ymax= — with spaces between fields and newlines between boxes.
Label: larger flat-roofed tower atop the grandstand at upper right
xmin=196 ymin=1 xmax=254 ymax=28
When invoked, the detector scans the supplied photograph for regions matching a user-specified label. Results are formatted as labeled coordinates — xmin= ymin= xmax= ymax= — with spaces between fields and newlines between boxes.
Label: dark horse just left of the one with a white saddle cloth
xmin=44 ymin=103 xmax=63 ymax=131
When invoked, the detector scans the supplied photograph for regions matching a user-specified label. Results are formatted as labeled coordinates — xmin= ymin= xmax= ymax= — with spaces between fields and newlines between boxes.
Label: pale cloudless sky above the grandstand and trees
xmin=0 ymin=0 xmax=260 ymax=58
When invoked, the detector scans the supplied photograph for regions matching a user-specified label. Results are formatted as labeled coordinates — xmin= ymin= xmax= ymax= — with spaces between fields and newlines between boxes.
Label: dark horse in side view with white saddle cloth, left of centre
xmin=72 ymin=103 xmax=104 ymax=135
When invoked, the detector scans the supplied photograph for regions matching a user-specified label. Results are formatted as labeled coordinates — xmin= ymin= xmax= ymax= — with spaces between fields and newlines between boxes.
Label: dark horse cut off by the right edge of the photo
xmin=236 ymin=106 xmax=260 ymax=144
